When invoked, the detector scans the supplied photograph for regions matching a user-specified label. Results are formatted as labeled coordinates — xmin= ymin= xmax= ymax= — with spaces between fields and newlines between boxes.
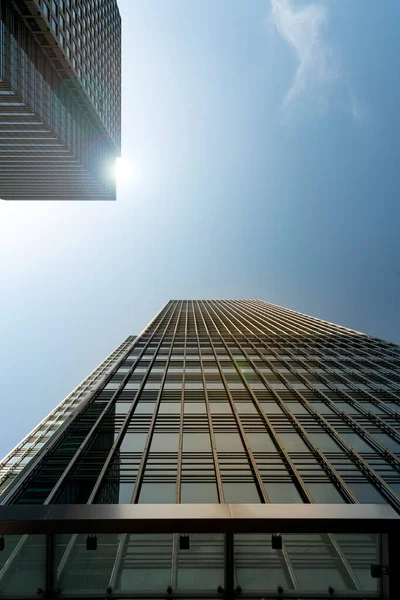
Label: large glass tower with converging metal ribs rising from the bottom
xmin=0 ymin=300 xmax=400 ymax=600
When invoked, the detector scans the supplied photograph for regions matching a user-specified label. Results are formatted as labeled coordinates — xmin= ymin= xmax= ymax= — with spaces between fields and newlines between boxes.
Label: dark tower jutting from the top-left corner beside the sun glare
xmin=0 ymin=0 xmax=121 ymax=200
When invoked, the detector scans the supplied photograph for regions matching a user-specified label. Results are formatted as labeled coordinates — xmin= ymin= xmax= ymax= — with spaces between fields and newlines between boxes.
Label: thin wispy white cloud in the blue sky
xmin=271 ymin=0 xmax=363 ymax=121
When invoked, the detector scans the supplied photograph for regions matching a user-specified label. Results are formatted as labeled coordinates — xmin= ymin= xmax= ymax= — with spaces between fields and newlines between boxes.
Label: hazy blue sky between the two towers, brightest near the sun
xmin=0 ymin=0 xmax=400 ymax=455
